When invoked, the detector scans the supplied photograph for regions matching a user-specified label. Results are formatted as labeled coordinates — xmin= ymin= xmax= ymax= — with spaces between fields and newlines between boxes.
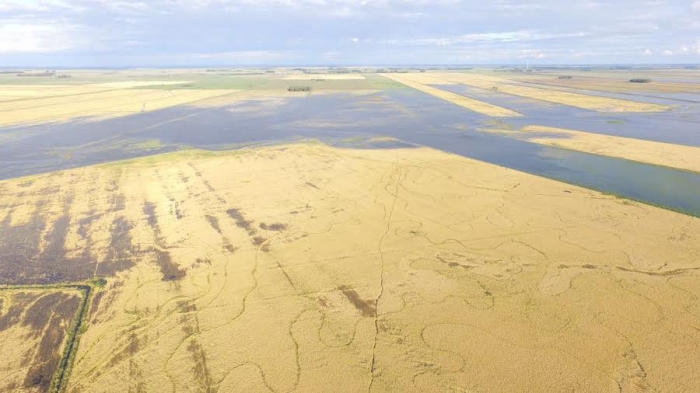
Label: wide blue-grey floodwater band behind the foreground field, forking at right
xmin=0 ymin=87 xmax=700 ymax=216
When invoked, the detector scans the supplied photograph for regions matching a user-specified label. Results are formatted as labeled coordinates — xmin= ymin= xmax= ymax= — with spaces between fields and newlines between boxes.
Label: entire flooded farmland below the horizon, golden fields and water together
xmin=0 ymin=67 xmax=700 ymax=392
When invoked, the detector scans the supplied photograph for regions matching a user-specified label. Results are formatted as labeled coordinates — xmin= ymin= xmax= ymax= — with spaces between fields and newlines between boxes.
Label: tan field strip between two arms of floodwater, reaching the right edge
xmin=521 ymin=126 xmax=700 ymax=172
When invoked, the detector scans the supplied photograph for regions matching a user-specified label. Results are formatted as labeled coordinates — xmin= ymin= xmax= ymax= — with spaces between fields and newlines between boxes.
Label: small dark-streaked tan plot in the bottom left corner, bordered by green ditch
xmin=0 ymin=289 xmax=80 ymax=392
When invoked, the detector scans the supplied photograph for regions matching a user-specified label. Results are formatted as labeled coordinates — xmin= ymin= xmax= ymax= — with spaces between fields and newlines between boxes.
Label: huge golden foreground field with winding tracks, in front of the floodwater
xmin=0 ymin=143 xmax=700 ymax=392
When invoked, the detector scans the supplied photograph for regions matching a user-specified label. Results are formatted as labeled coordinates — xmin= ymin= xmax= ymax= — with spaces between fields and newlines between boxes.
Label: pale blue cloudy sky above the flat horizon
xmin=0 ymin=0 xmax=700 ymax=67
